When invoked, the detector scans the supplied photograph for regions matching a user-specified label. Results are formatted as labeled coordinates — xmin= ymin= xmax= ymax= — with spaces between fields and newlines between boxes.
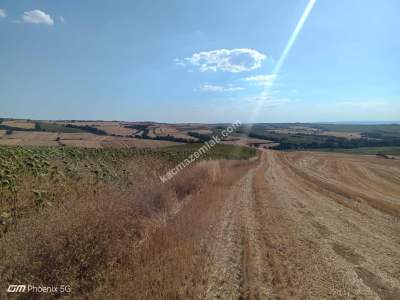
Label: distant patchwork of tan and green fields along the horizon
xmin=0 ymin=119 xmax=400 ymax=150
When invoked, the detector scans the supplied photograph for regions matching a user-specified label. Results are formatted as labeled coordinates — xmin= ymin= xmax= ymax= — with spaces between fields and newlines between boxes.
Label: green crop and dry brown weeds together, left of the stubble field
xmin=0 ymin=145 xmax=256 ymax=299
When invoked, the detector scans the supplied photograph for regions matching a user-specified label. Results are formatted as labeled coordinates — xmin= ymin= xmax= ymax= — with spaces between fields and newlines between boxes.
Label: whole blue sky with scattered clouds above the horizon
xmin=0 ymin=0 xmax=400 ymax=123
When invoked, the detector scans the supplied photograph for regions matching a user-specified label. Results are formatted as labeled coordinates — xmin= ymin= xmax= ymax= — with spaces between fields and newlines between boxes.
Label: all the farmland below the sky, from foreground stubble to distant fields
xmin=0 ymin=121 xmax=400 ymax=299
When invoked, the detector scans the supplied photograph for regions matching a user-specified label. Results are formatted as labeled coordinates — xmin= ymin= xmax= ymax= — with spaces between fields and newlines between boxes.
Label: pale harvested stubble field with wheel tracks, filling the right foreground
xmin=203 ymin=151 xmax=400 ymax=299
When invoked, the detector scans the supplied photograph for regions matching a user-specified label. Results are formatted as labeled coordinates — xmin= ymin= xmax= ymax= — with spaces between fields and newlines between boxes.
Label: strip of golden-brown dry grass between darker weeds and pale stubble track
xmin=96 ymin=162 xmax=256 ymax=299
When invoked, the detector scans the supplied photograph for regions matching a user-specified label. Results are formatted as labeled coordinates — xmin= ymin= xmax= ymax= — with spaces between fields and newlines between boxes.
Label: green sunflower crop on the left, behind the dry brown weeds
xmin=0 ymin=144 xmax=256 ymax=214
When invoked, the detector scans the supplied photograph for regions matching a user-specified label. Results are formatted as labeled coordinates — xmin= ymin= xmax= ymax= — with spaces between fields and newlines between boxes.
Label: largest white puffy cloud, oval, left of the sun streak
xmin=175 ymin=48 xmax=266 ymax=73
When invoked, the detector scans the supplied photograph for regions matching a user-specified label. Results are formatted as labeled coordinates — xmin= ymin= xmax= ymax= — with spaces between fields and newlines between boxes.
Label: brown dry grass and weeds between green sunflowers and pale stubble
xmin=0 ymin=152 xmax=256 ymax=299
